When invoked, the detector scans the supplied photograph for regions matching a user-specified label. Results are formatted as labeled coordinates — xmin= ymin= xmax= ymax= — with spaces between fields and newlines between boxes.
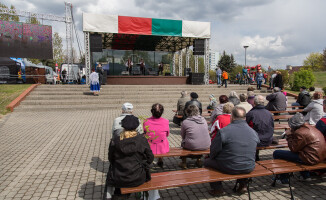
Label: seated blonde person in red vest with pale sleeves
xmin=211 ymin=102 xmax=234 ymax=140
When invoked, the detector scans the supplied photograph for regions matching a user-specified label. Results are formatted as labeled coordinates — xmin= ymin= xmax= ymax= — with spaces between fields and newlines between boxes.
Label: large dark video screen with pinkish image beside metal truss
xmin=0 ymin=20 xmax=53 ymax=59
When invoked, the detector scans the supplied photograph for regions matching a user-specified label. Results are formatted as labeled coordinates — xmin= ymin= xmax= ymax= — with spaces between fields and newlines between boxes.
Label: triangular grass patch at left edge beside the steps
xmin=0 ymin=84 xmax=31 ymax=115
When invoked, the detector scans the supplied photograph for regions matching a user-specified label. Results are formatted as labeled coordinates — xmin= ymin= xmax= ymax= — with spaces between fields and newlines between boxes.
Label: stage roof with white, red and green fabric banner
xmin=83 ymin=13 xmax=210 ymax=51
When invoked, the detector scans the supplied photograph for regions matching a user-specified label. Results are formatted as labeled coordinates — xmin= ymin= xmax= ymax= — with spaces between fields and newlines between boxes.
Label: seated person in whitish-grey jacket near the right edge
xmin=303 ymin=92 xmax=325 ymax=125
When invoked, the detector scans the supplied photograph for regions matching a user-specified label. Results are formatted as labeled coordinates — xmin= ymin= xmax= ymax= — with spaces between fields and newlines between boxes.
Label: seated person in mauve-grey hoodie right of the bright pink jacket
xmin=180 ymin=105 xmax=211 ymax=169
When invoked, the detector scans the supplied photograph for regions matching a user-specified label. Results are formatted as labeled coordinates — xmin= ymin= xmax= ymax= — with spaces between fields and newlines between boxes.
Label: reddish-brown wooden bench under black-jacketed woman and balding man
xmin=121 ymin=164 xmax=273 ymax=199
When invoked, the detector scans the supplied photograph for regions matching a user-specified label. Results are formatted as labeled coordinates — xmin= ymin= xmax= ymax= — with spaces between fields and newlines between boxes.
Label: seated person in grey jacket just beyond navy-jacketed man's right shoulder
xmin=266 ymin=87 xmax=287 ymax=111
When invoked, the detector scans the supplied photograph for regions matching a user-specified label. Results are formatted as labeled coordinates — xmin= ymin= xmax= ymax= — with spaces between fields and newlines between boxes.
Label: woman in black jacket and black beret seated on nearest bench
xmin=106 ymin=115 xmax=159 ymax=199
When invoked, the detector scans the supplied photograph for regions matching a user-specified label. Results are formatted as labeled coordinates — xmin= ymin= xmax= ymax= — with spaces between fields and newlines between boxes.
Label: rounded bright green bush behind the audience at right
xmin=290 ymin=69 xmax=316 ymax=91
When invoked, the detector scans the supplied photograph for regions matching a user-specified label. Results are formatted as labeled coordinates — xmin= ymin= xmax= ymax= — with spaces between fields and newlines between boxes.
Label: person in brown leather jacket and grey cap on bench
xmin=273 ymin=113 xmax=326 ymax=184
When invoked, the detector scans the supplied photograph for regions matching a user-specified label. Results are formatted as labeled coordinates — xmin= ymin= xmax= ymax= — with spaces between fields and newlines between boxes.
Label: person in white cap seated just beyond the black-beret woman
xmin=112 ymin=103 xmax=143 ymax=139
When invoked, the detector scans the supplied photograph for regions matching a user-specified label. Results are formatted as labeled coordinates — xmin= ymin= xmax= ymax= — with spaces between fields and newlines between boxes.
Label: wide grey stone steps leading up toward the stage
xmin=15 ymin=85 xmax=295 ymax=113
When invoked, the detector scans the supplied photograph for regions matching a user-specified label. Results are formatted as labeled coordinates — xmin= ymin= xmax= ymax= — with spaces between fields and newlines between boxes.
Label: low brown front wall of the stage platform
xmin=106 ymin=76 xmax=187 ymax=85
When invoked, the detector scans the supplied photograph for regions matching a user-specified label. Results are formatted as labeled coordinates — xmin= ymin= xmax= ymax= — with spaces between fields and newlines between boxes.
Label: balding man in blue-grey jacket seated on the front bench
xmin=204 ymin=107 xmax=259 ymax=196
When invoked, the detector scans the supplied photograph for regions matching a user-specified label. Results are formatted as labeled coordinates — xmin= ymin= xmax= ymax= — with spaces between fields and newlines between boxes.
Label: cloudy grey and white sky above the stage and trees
xmin=1 ymin=0 xmax=326 ymax=68
